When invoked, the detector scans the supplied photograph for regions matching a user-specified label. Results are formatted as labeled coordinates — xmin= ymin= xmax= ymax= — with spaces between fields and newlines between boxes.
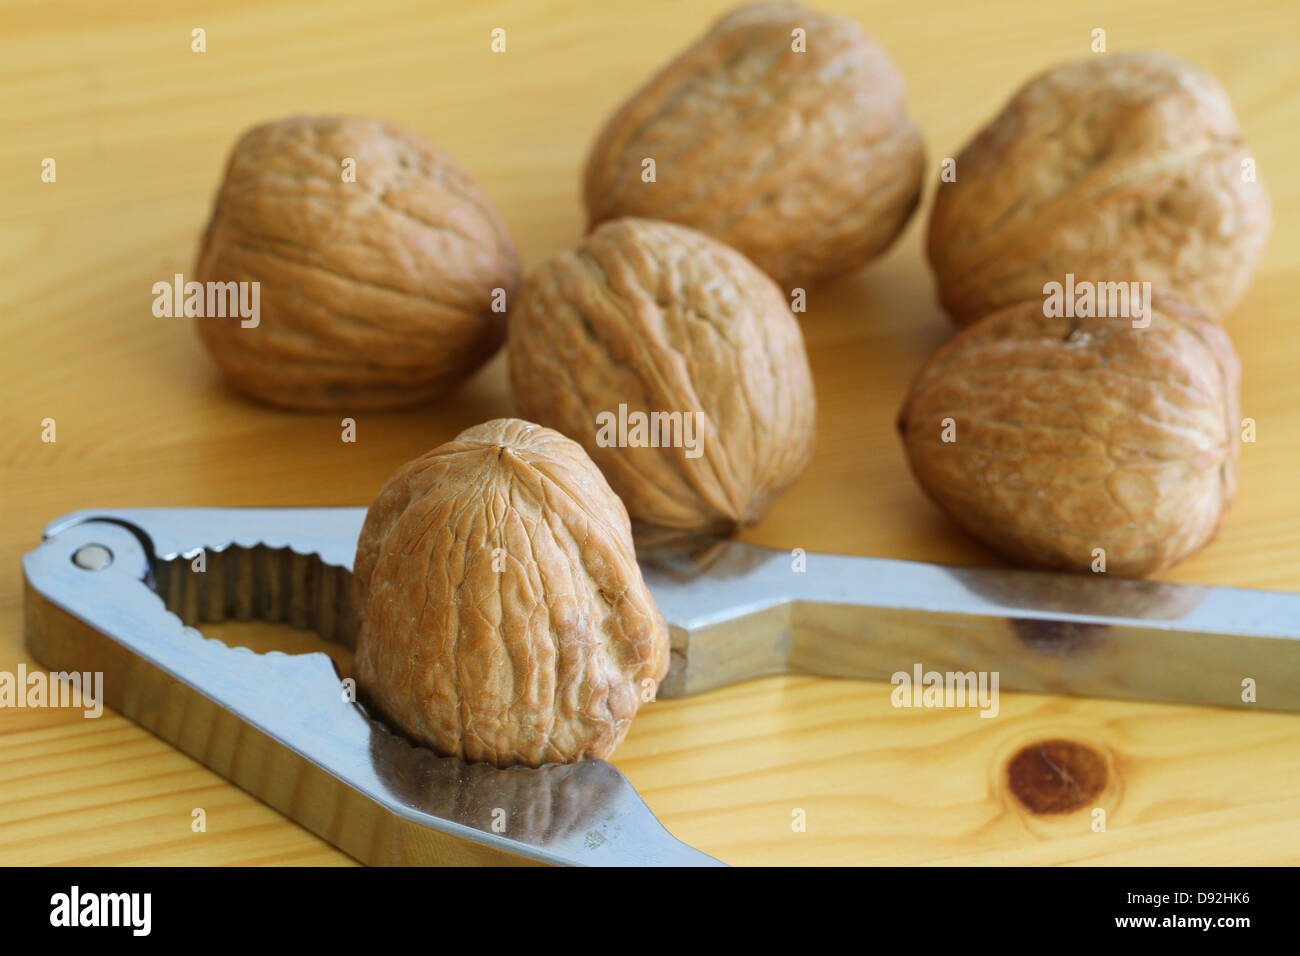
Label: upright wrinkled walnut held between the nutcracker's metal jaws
xmin=352 ymin=419 xmax=668 ymax=766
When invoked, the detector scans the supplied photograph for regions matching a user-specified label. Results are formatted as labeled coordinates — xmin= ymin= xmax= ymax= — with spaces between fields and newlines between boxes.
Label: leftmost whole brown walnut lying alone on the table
xmin=195 ymin=116 xmax=519 ymax=411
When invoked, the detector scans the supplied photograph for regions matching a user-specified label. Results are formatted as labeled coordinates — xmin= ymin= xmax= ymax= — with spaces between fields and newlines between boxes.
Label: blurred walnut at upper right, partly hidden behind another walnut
xmin=928 ymin=53 xmax=1271 ymax=324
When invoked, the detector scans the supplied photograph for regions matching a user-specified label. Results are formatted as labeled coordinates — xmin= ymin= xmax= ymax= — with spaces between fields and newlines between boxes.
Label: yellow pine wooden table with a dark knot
xmin=0 ymin=0 xmax=1300 ymax=864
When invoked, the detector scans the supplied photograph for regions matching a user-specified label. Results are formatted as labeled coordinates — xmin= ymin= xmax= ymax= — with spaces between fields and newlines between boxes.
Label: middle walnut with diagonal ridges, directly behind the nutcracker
xmin=508 ymin=219 xmax=816 ymax=533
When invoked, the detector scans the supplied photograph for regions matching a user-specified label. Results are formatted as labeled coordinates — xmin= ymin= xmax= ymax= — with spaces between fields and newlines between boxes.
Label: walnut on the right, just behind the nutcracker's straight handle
xmin=898 ymin=297 xmax=1240 ymax=575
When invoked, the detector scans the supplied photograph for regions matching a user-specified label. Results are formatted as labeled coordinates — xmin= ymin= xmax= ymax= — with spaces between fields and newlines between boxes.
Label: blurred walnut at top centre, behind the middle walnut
xmin=584 ymin=3 xmax=924 ymax=289
